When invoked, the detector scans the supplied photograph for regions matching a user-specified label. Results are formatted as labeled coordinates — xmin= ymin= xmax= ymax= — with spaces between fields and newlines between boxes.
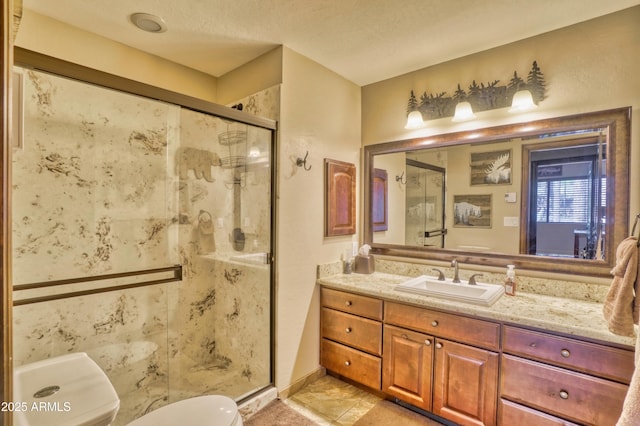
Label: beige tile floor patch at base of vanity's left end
xmin=284 ymin=376 xmax=380 ymax=426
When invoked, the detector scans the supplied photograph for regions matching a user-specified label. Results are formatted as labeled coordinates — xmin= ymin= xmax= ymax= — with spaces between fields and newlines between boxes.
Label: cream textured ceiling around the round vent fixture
xmin=24 ymin=0 xmax=640 ymax=86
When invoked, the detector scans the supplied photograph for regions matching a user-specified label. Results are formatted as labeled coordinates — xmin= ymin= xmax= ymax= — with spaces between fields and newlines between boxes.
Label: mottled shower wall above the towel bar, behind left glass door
xmin=12 ymin=71 xmax=179 ymax=283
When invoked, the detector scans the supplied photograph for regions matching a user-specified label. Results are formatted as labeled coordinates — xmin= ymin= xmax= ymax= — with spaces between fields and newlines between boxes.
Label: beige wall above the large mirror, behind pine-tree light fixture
xmin=362 ymin=6 xmax=640 ymax=280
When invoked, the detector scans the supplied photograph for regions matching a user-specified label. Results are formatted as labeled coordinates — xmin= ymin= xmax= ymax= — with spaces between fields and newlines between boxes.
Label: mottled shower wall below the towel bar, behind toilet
xmin=13 ymin=283 xmax=172 ymax=425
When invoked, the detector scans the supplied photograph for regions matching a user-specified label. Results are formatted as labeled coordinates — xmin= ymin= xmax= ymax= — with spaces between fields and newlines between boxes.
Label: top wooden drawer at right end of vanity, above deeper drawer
xmin=502 ymin=326 xmax=634 ymax=384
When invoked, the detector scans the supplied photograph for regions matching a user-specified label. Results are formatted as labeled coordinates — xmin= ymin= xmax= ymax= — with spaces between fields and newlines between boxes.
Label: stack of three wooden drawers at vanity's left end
xmin=320 ymin=288 xmax=383 ymax=390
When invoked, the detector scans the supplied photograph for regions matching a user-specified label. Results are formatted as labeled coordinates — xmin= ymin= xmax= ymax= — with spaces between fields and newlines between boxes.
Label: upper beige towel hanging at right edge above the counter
xmin=603 ymin=237 xmax=640 ymax=336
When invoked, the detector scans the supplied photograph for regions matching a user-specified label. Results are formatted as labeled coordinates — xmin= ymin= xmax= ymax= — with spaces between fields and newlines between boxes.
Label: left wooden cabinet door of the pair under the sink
xmin=382 ymin=325 xmax=434 ymax=411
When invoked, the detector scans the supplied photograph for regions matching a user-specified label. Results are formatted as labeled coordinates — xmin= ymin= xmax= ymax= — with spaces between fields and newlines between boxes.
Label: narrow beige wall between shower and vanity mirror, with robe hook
xmin=276 ymin=48 xmax=361 ymax=390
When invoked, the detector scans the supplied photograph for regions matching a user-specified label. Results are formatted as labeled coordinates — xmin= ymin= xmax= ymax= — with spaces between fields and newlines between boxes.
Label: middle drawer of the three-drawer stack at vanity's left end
xmin=321 ymin=308 xmax=382 ymax=356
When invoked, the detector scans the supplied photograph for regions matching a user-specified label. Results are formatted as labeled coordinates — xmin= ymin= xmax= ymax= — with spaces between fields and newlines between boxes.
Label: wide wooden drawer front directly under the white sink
xmin=384 ymin=302 xmax=500 ymax=351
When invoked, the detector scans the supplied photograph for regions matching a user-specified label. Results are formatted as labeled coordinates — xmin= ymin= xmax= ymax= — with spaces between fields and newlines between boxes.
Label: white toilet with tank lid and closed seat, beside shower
xmin=13 ymin=352 xmax=242 ymax=426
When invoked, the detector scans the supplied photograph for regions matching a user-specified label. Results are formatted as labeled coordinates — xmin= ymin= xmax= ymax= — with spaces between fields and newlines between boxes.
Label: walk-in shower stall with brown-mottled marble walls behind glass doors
xmin=11 ymin=56 xmax=275 ymax=426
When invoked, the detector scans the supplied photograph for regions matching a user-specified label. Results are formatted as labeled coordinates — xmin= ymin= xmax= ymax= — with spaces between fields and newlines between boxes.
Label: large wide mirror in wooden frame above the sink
xmin=364 ymin=108 xmax=631 ymax=276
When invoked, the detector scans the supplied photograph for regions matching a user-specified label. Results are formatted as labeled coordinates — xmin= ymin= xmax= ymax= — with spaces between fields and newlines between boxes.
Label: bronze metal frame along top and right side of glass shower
xmin=10 ymin=47 xmax=277 ymax=402
